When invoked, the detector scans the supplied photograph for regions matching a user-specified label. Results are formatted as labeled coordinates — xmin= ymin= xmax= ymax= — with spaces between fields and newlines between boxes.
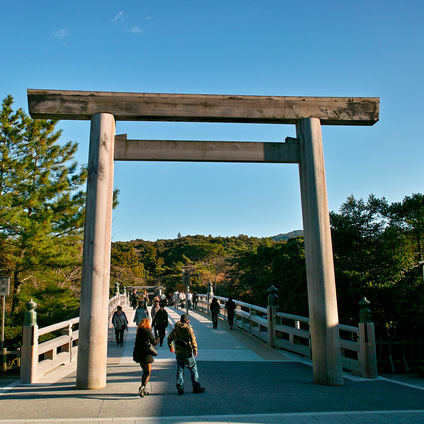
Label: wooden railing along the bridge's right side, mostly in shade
xmin=197 ymin=294 xmax=377 ymax=378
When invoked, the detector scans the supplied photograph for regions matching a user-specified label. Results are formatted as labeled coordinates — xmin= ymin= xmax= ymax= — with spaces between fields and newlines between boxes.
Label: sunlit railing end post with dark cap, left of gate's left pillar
xmin=20 ymin=299 xmax=38 ymax=384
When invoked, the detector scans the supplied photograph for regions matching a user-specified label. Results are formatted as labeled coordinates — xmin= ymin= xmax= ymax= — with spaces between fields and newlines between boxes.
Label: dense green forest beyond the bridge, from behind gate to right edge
xmin=111 ymin=190 xmax=424 ymax=344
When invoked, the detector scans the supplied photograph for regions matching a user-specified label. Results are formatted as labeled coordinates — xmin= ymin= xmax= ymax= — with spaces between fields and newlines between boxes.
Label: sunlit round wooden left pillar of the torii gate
xmin=77 ymin=113 xmax=115 ymax=389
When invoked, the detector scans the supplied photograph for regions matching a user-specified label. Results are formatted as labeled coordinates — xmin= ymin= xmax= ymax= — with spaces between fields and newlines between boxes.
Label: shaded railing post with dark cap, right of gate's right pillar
xmin=359 ymin=297 xmax=378 ymax=378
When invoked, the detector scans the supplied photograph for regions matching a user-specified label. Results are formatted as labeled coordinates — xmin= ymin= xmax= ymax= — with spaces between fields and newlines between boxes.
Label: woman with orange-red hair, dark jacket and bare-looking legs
xmin=133 ymin=318 xmax=156 ymax=397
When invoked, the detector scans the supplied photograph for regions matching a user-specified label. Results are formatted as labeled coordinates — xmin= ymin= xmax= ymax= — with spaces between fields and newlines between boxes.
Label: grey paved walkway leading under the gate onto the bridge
xmin=0 ymin=309 xmax=424 ymax=424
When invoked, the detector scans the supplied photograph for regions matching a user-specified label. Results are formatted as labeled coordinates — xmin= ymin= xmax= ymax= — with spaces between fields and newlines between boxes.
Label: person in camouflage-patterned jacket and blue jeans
xmin=168 ymin=314 xmax=205 ymax=395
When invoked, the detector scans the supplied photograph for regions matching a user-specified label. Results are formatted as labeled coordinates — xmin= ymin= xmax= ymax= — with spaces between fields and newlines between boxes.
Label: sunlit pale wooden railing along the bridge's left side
xmin=20 ymin=291 xmax=128 ymax=383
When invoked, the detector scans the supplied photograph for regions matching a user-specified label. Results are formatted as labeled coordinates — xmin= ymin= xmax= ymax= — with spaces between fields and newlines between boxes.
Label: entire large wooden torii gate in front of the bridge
xmin=28 ymin=90 xmax=379 ymax=389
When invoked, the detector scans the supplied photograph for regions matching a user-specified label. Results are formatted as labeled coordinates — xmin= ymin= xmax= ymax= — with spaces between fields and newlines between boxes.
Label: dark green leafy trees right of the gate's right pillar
xmin=330 ymin=195 xmax=424 ymax=337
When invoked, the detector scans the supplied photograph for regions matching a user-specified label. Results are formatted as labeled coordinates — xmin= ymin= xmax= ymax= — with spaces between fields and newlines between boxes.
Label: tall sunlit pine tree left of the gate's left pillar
xmin=0 ymin=96 xmax=87 ymax=313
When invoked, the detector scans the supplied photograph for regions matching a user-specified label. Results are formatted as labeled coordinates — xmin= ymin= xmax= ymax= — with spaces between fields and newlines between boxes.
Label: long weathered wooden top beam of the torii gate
xmin=28 ymin=89 xmax=380 ymax=125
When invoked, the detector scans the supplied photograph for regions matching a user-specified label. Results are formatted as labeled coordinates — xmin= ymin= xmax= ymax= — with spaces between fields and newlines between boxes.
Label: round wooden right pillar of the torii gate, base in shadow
xmin=296 ymin=118 xmax=343 ymax=385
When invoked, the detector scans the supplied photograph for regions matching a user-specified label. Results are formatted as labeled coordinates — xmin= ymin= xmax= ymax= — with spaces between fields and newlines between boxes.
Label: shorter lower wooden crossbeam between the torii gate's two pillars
xmin=115 ymin=135 xmax=300 ymax=163
